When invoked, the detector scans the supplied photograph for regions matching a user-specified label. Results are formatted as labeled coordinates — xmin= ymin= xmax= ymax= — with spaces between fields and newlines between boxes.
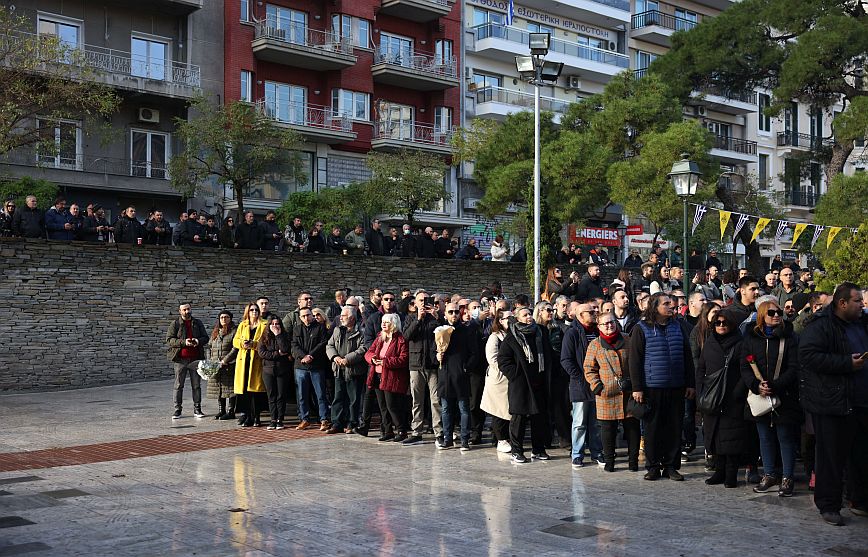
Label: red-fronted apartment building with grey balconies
xmin=224 ymin=0 xmax=462 ymax=226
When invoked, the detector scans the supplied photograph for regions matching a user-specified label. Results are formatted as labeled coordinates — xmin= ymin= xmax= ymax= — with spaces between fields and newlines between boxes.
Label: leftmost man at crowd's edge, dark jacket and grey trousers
xmin=166 ymin=303 xmax=208 ymax=420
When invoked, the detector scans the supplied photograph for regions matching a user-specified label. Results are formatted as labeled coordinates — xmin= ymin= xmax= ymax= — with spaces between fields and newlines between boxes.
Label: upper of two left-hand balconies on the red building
xmin=251 ymin=21 xmax=356 ymax=71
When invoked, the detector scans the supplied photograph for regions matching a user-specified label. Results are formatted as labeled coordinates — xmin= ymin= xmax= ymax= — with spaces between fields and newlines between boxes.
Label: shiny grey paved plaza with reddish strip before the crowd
xmin=0 ymin=381 xmax=868 ymax=557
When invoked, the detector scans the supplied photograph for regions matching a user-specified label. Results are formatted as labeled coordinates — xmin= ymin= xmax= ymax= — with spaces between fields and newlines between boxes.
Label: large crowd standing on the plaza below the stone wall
xmin=166 ymin=256 xmax=868 ymax=525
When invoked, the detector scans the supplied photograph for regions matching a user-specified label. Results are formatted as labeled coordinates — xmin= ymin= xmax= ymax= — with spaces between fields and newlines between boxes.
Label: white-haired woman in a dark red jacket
xmin=365 ymin=313 xmax=410 ymax=443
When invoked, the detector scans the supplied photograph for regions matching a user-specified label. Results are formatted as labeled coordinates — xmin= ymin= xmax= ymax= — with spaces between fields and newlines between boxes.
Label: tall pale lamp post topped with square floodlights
xmin=515 ymin=33 xmax=564 ymax=304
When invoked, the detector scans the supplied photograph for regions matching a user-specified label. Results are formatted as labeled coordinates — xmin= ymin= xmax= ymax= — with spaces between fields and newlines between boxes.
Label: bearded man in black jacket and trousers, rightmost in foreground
xmin=799 ymin=282 xmax=868 ymax=526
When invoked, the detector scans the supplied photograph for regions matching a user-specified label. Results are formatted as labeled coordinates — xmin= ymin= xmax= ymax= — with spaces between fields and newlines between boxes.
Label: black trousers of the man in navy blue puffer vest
xmin=642 ymin=387 xmax=684 ymax=470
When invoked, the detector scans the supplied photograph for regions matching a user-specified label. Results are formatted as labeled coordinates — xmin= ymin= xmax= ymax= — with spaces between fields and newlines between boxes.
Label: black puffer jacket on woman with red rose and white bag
xmin=739 ymin=321 xmax=804 ymax=424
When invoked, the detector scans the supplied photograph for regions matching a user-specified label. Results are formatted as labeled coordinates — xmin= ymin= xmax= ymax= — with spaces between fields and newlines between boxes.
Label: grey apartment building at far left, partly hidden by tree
xmin=0 ymin=0 xmax=223 ymax=220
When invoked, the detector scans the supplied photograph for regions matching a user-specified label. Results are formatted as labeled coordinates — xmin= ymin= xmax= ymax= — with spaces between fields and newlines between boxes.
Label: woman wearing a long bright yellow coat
xmin=232 ymin=303 xmax=266 ymax=427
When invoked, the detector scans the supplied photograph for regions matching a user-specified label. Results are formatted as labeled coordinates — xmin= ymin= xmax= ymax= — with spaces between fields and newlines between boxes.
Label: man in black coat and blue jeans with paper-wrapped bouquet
xmin=437 ymin=303 xmax=479 ymax=451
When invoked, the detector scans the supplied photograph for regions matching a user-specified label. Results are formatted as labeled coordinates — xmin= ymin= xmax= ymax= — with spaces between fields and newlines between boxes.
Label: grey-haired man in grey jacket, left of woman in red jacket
xmin=326 ymin=306 xmax=368 ymax=434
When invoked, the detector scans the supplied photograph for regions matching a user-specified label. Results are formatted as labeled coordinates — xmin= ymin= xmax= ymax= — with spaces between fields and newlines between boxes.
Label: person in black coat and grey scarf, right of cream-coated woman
xmin=497 ymin=308 xmax=554 ymax=464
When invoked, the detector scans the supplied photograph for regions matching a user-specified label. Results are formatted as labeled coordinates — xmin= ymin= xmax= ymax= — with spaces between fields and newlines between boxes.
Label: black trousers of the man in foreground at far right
xmin=812 ymin=414 xmax=857 ymax=513
